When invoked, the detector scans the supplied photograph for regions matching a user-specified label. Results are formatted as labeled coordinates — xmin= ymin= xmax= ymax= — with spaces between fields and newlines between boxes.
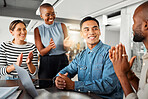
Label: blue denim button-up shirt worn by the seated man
xmin=57 ymin=40 xmax=123 ymax=99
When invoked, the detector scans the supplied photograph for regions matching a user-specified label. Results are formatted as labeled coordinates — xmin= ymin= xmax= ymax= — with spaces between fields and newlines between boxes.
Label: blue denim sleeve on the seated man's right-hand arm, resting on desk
xmin=75 ymin=51 xmax=121 ymax=94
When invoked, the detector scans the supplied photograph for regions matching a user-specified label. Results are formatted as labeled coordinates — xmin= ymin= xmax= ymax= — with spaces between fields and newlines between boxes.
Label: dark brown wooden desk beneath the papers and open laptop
xmin=0 ymin=80 xmax=102 ymax=99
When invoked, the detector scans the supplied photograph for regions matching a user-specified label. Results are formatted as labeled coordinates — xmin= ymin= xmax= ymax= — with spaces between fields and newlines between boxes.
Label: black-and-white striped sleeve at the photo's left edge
xmin=0 ymin=42 xmax=7 ymax=76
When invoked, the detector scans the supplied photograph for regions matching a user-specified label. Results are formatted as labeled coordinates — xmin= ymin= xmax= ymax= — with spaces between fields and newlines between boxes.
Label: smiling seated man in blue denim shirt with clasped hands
xmin=55 ymin=17 xmax=123 ymax=99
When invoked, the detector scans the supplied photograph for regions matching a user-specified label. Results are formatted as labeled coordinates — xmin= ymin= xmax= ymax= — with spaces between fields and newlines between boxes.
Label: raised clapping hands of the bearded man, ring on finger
xmin=109 ymin=43 xmax=136 ymax=77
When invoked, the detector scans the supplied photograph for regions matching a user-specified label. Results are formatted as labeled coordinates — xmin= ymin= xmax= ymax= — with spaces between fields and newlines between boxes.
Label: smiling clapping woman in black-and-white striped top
xmin=0 ymin=20 xmax=38 ymax=80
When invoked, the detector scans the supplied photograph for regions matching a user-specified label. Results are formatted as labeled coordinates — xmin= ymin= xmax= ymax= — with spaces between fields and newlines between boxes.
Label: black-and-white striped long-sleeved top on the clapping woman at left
xmin=0 ymin=41 xmax=38 ymax=76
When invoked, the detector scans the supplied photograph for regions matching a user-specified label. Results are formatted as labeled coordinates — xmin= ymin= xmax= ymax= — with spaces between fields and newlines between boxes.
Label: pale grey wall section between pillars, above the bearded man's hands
xmin=105 ymin=27 xmax=120 ymax=46
